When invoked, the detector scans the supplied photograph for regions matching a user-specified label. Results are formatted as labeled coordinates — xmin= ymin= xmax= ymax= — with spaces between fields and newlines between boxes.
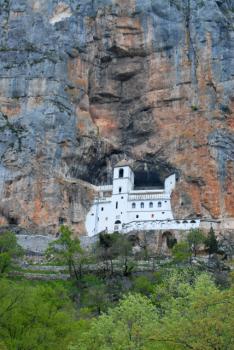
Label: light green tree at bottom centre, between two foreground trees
xmin=75 ymin=294 xmax=157 ymax=350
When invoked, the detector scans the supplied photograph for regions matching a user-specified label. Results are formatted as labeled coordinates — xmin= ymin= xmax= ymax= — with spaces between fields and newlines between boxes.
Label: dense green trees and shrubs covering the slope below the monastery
xmin=0 ymin=226 xmax=234 ymax=350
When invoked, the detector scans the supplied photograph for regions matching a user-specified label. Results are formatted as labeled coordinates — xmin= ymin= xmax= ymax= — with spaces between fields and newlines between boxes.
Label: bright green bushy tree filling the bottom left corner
xmin=0 ymin=279 xmax=78 ymax=350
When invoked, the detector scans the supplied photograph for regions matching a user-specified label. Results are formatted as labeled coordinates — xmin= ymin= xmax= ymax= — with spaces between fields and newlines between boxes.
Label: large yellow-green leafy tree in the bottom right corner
xmin=151 ymin=274 xmax=234 ymax=350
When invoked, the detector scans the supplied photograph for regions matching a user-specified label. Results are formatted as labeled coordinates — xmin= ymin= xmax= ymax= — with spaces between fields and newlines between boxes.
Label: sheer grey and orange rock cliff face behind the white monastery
xmin=0 ymin=0 xmax=234 ymax=233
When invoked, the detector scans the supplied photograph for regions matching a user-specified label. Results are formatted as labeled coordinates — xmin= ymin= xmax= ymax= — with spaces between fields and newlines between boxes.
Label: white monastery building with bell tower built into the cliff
xmin=86 ymin=160 xmax=200 ymax=236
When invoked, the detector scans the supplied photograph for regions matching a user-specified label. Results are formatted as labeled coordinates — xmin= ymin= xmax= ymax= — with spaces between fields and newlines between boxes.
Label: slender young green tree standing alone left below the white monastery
xmin=47 ymin=225 xmax=84 ymax=280
